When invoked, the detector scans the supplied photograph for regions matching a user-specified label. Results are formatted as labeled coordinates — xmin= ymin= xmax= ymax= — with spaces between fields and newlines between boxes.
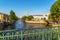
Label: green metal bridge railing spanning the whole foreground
xmin=0 ymin=27 xmax=60 ymax=40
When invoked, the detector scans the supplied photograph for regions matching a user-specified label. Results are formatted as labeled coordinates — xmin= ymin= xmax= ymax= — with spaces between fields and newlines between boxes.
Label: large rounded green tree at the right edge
xmin=49 ymin=0 xmax=60 ymax=20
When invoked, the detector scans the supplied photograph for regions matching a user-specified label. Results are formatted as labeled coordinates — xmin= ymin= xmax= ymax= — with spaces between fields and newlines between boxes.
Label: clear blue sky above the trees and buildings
xmin=0 ymin=0 xmax=56 ymax=17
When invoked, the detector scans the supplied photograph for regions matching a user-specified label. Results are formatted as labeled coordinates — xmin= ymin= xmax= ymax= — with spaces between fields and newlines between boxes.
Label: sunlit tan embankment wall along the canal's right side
xmin=25 ymin=20 xmax=60 ymax=27
